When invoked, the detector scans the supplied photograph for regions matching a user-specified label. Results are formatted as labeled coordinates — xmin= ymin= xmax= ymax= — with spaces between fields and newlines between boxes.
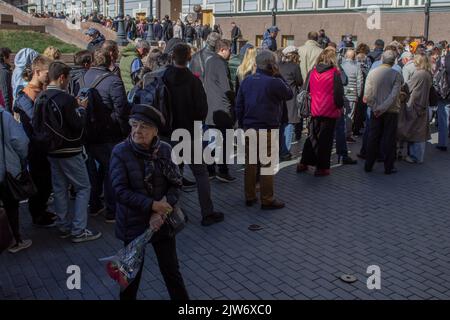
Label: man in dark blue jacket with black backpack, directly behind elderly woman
xmin=81 ymin=50 xmax=130 ymax=222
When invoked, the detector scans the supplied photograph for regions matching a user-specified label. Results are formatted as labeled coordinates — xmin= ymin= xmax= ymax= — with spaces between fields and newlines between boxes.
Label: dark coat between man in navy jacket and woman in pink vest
xmin=280 ymin=62 xmax=303 ymax=123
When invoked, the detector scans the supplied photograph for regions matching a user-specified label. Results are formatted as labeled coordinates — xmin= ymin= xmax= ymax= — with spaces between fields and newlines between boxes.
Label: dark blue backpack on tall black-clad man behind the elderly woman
xmin=133 ymin=68 xmax=173 ymax=137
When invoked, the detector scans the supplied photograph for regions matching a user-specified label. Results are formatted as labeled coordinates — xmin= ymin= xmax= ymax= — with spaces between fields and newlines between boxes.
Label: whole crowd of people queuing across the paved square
xmin=0 ymin=20 xmax=450 ymax=299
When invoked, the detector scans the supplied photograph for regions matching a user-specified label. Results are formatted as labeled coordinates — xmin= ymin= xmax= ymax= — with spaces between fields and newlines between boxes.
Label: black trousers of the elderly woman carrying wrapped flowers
xmin=120 ymin=231 xmax=189 ymax=301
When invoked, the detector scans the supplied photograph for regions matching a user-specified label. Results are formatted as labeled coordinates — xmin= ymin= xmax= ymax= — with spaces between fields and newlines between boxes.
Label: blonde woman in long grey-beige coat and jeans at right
xmin=399 ymin=55 xmax=432 ymax=163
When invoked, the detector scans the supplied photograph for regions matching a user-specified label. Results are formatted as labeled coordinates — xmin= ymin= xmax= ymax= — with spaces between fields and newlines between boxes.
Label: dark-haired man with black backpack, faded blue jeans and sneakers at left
xmin=32 ymin=61 xmax=102 ymax=243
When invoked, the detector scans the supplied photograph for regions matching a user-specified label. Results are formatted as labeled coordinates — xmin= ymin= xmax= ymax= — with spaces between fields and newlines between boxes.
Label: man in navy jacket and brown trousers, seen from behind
xmin=236 ymin=50 xmax=294 ymax=210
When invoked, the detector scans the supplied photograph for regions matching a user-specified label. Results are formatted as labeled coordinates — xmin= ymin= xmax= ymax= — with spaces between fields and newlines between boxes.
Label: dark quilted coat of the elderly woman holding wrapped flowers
xmin=109 ymin=140 xmax=179 ymax=242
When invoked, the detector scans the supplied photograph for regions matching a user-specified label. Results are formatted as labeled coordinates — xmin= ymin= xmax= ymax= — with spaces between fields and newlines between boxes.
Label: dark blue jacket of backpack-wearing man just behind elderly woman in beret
xmin=84 ymin=67 xmax=130 ymax=143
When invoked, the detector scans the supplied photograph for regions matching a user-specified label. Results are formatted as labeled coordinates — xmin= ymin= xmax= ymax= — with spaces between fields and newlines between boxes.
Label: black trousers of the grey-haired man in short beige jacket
xmin=365 ymin=112 xmax=398 ymax=172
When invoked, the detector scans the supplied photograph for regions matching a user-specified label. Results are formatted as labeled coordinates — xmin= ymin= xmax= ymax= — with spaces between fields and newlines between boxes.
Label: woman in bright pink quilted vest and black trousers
xmin=297 ymin=48 xmax=344 ymax=177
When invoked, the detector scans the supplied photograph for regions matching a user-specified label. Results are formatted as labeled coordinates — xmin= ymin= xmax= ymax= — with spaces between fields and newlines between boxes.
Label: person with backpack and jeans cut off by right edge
xmin=433 ymin=46 xmax=450 ymax=151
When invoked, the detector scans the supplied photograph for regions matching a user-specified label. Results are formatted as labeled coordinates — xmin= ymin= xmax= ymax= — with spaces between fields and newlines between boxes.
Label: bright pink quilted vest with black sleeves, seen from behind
xmin=309 ymin=64 xmax=344 ymax=118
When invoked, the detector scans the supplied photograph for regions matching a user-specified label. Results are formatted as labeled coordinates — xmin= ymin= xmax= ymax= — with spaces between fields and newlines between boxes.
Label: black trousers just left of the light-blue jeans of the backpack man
xmin=28 ymin=148 xmax=52 ymax=220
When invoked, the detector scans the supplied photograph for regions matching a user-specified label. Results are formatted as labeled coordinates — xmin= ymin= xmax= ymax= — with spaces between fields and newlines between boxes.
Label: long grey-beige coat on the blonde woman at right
xmin=398 ymin=69 xmax=432 ymax=142
